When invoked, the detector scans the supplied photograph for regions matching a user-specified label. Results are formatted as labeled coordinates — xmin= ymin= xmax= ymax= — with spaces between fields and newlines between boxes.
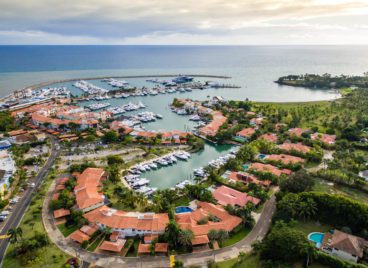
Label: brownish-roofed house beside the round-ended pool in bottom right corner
xmin=320 ymin=230 xmax=368 ymax=262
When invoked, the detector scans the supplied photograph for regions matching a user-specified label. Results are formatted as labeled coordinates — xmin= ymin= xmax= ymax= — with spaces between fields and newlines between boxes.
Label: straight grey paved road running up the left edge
xmin=0 ymin=139 xmax=59 ymax=267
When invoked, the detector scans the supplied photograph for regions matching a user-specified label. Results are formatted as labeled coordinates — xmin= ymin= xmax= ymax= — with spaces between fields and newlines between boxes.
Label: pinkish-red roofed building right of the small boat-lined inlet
xmin=212 ymin=185 xmax=261 ymax=207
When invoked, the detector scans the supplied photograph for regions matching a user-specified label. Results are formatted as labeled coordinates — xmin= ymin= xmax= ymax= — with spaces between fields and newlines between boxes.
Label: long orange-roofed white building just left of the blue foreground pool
xmin=84 ymin=206 xmax=169 ymax=238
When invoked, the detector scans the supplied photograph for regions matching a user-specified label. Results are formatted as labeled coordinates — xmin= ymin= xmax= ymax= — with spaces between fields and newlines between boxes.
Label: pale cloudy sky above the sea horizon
xmin=0 ymin=0 xmax=368 ymax=45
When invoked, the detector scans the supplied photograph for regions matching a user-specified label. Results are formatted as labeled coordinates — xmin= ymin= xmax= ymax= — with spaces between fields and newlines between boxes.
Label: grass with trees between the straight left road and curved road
xmin=3 ymin=171 xmax=70 ymax=268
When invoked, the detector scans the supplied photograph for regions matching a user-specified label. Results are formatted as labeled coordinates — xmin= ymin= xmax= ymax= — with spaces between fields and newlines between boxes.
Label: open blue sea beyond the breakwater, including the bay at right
xmin=0 ymin=46 xmax=368 ymax=101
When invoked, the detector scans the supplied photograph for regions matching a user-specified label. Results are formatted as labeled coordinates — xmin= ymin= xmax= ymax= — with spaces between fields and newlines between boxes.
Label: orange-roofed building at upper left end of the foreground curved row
xmin=74 ymin=168 xmax=107 ymax=212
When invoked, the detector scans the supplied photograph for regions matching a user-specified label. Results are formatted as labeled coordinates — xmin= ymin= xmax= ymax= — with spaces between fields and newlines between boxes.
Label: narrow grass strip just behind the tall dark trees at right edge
xmin=313 ymin=179 xmax=368 ymax=203
